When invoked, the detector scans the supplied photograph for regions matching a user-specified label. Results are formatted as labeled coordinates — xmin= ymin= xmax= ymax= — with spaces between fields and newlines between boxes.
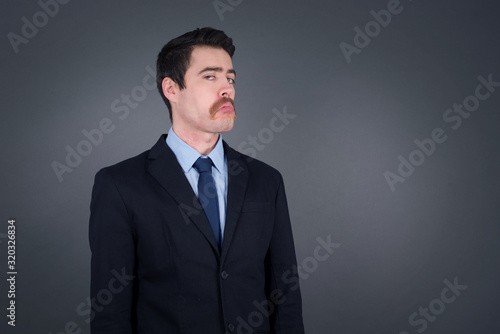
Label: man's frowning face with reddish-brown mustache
xmin=173 ymin=46 xmax=236 ymax=135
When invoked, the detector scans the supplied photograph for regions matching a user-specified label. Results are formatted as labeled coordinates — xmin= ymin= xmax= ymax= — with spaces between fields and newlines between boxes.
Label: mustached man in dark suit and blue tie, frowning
xmin=89 ymin=28 xmax=304 ymax=334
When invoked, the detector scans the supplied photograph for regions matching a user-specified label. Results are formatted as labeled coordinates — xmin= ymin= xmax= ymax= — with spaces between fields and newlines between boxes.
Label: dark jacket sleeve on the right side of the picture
xmin=267 ymin=175 xmax=304 ymax=334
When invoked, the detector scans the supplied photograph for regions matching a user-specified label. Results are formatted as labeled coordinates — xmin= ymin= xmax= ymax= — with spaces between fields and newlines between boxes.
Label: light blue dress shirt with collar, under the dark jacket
xmin=166 ymin=127 xmax=227 ymax=241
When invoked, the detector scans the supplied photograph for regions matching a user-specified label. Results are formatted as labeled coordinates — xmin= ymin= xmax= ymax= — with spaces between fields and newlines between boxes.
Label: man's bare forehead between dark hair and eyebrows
xmin=188 ymin=46 xmax=233 ymax=71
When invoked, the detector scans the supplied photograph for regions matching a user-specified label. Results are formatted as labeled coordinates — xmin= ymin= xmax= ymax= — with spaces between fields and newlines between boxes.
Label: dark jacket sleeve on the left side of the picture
xmin=89 ymin=169 xmax=136 ymax=334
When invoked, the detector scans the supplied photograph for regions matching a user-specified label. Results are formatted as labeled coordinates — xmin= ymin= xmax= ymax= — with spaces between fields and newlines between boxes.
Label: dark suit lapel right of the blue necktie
xmin=221 ymin=142 xmax=248 ymax=264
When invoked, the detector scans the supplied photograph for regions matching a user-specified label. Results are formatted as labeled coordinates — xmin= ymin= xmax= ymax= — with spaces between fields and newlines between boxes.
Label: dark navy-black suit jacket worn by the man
xmin=89 ymin=135 xmax=304 ymax=334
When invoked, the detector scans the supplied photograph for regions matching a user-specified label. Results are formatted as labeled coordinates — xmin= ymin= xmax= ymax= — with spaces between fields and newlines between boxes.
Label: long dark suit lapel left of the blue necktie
xmin=148 ymin=135 xmax=221 ymax=255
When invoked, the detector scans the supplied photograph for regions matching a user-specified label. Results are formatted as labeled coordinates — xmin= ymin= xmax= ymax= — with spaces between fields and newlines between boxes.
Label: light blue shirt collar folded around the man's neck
xmin=166 ymin=127 xmax=224 ymax=174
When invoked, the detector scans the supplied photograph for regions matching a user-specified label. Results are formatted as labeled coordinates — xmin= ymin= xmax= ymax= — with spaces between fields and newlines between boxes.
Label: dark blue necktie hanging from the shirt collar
xmin=193 ymin=157 xmax=221 ymax=249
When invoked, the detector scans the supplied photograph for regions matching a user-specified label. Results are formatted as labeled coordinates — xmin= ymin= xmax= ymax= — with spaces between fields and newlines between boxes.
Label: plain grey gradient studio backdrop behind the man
xmin=0 ymin=0 xmax=500 ymax=334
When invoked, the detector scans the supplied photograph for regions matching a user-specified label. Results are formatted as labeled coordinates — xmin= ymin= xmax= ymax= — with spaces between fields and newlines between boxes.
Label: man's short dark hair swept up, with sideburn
xmin=156 ymin=27 xmax=235 ymax=120
